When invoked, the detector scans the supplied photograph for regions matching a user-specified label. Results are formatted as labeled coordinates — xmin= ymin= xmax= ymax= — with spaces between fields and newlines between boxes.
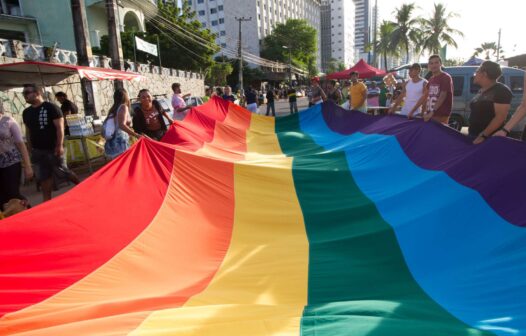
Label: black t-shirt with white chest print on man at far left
xmin=22 ymin=102 xmax=63 ymax=150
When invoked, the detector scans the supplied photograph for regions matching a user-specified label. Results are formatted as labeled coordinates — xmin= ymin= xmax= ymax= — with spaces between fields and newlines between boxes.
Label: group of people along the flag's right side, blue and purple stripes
xmin=310 ymin=55 xmax=526 ymax=144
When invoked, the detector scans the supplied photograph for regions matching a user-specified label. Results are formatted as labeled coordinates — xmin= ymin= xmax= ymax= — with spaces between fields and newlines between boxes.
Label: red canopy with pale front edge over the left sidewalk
xmin=0 ymin=61 xmax=142 ymax=90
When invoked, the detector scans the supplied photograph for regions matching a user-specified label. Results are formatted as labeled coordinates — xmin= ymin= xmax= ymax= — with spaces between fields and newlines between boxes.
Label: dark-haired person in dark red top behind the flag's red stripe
xmin=133 ymin=89 xmax=173 ymax=141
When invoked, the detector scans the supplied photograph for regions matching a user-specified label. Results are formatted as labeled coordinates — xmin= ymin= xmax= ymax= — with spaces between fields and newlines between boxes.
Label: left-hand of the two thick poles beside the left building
xmin=71 ymin=0 xmax=97 ymax=116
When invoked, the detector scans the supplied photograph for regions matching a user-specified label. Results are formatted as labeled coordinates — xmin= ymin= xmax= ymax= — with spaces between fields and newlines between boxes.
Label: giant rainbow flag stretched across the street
xmin=0 ymin=99 xmax=526 ymax=336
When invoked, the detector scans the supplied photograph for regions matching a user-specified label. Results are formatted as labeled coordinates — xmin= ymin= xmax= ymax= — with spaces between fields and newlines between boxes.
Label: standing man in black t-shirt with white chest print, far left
xmin=22 ymin=84 xmax=79 ymax=202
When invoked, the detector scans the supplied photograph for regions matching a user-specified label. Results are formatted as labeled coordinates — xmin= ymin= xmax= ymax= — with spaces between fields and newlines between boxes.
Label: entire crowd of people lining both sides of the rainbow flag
xmin=0 ymin=55 xmax=526 ymax=210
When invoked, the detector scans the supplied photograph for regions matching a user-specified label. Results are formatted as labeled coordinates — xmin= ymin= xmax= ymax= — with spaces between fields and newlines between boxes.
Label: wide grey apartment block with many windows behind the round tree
xmin=186 ymin=0 xmax=321 ymax=65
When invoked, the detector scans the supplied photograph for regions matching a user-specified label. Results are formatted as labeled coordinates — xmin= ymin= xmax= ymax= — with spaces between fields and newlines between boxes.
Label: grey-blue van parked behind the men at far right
xmin=444 ymin=66 xmax=526 ymax=138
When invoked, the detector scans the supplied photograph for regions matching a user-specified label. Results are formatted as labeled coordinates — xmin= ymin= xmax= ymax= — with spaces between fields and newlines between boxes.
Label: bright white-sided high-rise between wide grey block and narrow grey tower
xmin=321 ymin=0 xmax=355 ymax=72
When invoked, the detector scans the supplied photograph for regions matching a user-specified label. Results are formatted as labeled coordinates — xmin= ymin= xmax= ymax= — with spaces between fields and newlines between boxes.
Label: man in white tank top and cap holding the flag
xmin=389 ymin=63 xmax=427 ymax=119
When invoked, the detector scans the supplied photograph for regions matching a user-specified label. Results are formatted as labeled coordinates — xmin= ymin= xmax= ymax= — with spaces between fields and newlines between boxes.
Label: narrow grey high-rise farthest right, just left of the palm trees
xmin=353 ymin=0 xmax=373 ymax=62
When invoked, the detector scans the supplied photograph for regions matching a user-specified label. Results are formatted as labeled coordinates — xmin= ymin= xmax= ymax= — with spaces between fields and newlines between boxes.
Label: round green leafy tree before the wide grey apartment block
xmin=261 ymin=19 xmax=318 ymax=74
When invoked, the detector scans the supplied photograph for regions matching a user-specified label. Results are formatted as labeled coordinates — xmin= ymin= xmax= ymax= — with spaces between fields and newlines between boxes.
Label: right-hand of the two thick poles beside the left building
xmin=106 ymin=0 xmax=124 ymax=89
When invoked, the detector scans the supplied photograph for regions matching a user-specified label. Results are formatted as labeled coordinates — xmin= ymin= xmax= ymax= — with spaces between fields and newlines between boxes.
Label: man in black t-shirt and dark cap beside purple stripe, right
xmin=469 ymin=61 xmax=513 ymax=144
